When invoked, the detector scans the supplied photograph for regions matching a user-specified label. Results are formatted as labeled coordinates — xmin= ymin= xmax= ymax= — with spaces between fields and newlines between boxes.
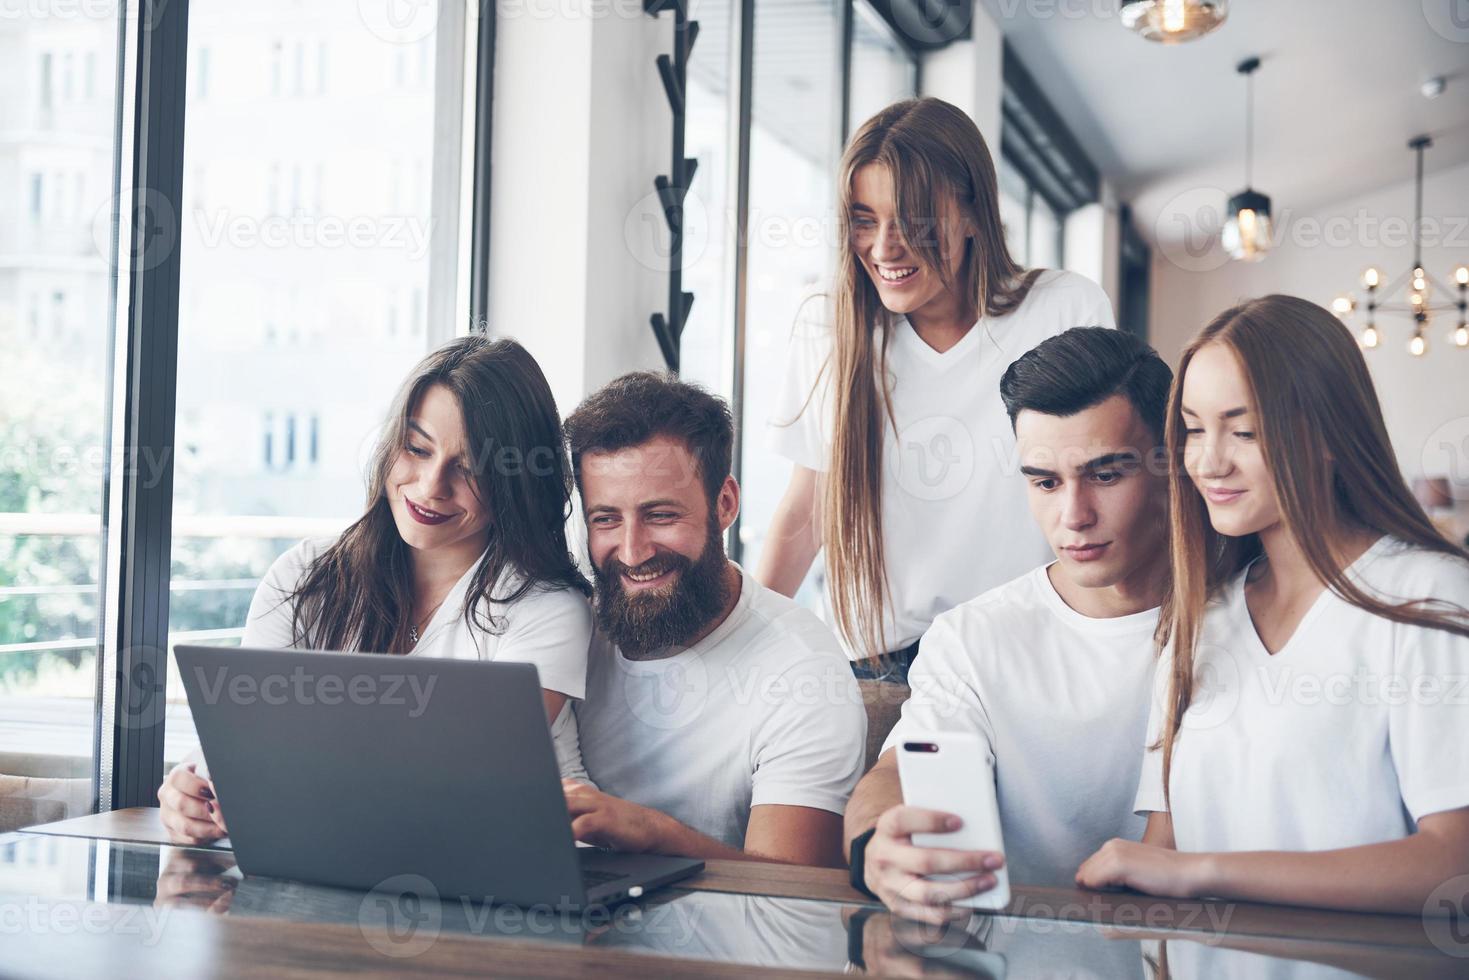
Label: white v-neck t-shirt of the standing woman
xmin=768 ymin=270 xmax=1115 ymax=657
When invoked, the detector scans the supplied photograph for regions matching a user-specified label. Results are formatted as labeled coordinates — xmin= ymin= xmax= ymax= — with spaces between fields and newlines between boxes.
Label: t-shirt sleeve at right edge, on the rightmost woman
xmin=1388 ymin=554 xmax=1469 ymax=820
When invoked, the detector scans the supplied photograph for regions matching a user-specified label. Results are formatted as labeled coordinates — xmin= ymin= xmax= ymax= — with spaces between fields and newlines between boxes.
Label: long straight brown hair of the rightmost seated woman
xmin=1152 ymin=295 xmax=1469 ymax=799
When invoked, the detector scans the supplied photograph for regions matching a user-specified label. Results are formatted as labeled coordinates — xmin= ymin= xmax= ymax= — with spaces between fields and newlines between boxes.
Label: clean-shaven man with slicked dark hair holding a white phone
xmin=846 ymin=328 xmax=1172 ymax=921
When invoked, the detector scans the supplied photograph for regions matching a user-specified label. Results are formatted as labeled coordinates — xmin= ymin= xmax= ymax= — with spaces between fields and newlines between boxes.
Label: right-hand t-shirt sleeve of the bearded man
xmin=749 ymin=651 xmax=867 ymax=814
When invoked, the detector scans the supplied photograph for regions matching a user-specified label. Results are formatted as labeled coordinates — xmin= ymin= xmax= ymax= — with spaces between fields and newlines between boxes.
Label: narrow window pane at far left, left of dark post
xmin=0 ymin=4 xmax=118 ymax=830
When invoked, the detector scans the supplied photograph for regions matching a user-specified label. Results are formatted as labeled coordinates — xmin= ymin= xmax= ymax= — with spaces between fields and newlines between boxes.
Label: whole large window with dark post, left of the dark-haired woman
xmin=0 ymin=0 xmax=494 ymax=830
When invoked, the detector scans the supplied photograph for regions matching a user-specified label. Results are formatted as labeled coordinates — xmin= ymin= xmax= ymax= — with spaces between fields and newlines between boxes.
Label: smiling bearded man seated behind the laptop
xmin=566 ymin=372 xmax=867 ymax=865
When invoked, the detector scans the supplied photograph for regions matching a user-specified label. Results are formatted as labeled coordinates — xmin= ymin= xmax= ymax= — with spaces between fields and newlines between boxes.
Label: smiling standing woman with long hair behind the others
xmin=757 ymin=98 xmax=1114 ymax=677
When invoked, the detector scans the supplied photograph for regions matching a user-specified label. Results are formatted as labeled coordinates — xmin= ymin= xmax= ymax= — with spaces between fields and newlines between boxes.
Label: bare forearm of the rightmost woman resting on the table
xmin=1077 ymin=807 xmax=1469 ymax=915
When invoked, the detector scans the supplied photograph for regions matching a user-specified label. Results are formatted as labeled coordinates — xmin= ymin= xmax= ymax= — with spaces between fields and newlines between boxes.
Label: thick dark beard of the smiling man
xmin=592 ymin=517 xmax=730 ymax=660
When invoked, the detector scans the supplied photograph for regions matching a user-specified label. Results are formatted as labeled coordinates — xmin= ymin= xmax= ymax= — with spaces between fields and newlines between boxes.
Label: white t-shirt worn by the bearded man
xmin=576 ymin=569 xmax=867 ymax=848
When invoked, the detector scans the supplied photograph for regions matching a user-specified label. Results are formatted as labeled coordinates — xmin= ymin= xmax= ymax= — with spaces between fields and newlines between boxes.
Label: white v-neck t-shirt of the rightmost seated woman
xmin=1136 ymin=536 xmax=1469 ymax=851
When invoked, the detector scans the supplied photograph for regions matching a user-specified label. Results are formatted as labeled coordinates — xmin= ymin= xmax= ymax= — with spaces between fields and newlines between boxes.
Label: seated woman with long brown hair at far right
xmin=1077 ymin=295 xmax=1469 ymax=914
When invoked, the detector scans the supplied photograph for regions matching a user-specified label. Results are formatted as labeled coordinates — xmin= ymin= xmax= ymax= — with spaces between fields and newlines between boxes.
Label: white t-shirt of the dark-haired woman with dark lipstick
xmin=239 ymin=538 xmax=592 ymax=779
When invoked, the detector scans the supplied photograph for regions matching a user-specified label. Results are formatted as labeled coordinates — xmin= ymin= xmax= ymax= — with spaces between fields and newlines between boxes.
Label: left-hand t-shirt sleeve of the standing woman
xmin=765 ymin=297 xmax=831 ymax=472
